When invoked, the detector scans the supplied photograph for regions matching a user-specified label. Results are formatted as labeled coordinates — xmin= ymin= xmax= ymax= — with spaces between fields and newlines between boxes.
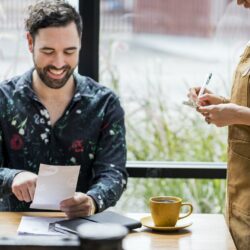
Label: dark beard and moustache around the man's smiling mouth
xmin=35 ymin=64 xmax=75 ymax=89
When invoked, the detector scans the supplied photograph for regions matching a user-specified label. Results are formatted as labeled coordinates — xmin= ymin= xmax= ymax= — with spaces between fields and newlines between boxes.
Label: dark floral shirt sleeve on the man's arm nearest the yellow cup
xmin=87 ymin=94 xmax=128 ymax=212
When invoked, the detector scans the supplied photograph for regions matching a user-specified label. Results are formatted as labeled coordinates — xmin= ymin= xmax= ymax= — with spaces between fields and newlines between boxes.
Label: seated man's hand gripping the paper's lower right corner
xmin=60 ymin=192 xmax=96 ymax=218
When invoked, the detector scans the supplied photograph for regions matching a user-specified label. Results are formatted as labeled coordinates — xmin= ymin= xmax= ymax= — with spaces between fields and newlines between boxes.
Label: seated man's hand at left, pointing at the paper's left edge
xmin=11 ymin=171 xmax=37 ymax=202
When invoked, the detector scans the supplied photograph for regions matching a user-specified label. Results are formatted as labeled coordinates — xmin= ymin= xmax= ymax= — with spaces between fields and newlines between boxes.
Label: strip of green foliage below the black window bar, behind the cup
xmin=116 ymin=178 xmax=225 ymax=213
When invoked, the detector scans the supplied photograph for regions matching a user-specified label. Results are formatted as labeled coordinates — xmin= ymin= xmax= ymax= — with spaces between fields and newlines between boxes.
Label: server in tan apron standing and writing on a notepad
xmin=188 ymin=0 xmax=250 ymax=250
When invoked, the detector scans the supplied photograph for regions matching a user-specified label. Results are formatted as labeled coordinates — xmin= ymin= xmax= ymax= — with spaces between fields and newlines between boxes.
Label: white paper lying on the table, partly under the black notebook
xmin=17 ymin=216 xmax=65 ymax=236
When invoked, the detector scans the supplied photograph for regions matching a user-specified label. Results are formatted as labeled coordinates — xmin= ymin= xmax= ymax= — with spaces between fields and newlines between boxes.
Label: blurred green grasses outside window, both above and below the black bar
xmin=114 ymin=92 xmax=227 ymax=213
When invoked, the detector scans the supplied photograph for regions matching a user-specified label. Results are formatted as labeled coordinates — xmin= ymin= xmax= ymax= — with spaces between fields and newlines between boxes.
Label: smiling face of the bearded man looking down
xmin=27 ymin=22 xmax=81 ymax=89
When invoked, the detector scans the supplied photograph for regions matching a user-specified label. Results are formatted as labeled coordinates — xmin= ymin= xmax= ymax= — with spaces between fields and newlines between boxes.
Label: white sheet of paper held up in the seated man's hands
xmin=30 ymin=164 xmax=80 ymax=210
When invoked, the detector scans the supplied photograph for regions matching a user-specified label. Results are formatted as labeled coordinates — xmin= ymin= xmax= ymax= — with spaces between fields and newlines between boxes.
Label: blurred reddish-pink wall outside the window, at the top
xmin=133 ymin=0 xmax=228 ymax=36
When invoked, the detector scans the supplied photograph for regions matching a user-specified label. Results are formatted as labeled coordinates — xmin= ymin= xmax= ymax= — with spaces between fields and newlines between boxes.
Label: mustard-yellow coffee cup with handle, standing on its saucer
xmin=149 ymin=196 xmax=193 ymax=227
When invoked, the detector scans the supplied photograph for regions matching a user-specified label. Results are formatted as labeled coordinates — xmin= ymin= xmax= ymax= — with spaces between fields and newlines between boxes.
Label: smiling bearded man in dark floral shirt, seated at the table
xmin=0 ymin=0 xmax=127 ymax=218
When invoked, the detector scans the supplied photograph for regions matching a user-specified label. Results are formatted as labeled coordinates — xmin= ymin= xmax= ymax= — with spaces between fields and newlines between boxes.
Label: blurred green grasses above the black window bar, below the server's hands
xmin=125 ymin=101 xmax=226 ymax=162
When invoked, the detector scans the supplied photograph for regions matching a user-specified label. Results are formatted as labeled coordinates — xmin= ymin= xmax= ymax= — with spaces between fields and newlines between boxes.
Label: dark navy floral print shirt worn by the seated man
xmin=0 ymin=69 xmax=127 ymax=212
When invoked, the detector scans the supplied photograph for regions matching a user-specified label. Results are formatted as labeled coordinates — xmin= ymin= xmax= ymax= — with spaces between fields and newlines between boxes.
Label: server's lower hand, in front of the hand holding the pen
xmin=198 ymin=103 xmax=240 ymax=127
